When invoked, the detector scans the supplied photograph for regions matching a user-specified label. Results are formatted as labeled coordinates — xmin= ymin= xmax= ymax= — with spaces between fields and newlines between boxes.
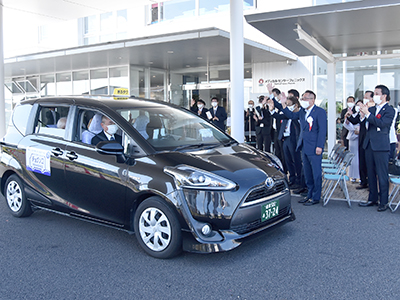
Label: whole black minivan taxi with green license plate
xmin=0 ymin=97 xmax=295 ymax=258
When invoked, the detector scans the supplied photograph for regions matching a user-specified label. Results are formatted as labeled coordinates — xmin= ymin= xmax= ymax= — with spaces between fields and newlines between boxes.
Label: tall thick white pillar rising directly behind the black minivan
xmin=230 ymin=0 xmax=244 ymax=143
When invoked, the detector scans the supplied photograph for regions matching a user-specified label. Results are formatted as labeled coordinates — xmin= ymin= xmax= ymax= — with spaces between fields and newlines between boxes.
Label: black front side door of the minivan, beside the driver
xmin=65 ymin=109 xmax=128 ymax=226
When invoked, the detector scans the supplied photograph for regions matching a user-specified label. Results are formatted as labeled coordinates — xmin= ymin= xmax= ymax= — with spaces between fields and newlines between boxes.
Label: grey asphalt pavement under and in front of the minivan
xmin=0 ymin=193 xmax=400 ymax=300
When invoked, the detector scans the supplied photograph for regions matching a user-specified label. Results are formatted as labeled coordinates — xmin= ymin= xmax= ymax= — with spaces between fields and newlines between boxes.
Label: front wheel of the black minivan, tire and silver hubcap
xmin=134 ymin=197 xmax=182 ymax=258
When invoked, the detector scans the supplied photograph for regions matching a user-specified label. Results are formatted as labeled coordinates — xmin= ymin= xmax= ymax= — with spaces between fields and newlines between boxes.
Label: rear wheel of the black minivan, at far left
xmin=4 ymin=175 xmax=33 ymax=218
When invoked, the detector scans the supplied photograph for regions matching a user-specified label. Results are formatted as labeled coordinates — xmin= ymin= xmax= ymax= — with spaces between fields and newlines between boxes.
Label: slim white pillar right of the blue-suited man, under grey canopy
xmin=327 ymin=62 xmax=336 ymax=153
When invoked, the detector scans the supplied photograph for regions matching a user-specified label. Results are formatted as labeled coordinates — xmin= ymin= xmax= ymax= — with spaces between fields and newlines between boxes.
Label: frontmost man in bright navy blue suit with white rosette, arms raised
xmin=269 ymin=90 xmax=327 ymax=206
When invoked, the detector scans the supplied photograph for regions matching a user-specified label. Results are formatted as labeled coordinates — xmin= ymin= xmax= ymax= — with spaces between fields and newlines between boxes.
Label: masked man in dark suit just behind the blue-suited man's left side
xmin=268 ymin=96 xmax=303 ymax=190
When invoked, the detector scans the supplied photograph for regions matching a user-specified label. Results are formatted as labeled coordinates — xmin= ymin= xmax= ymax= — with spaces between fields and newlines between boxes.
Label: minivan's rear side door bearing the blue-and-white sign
xmin=18 ymin=104 xmax=70 ymax=205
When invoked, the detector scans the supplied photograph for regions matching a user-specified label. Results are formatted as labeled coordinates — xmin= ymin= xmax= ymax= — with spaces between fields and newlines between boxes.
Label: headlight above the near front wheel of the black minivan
xmin=164 ymin=165 xmax=236 ymax=191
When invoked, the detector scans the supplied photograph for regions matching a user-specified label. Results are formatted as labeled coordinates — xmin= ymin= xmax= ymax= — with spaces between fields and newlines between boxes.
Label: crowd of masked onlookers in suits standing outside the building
xmin=191 ymin=84 xmax=398 ymax=211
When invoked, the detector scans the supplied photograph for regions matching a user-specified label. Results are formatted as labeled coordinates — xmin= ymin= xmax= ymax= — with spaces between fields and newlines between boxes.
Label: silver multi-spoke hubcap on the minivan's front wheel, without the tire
xmin=139 ymin=207 xmax=171 ymax=252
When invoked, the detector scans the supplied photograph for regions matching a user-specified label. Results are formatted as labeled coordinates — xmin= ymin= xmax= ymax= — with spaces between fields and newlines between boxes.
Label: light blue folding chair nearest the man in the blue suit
xmin=323 ymin=152 xmax=354 ymax=207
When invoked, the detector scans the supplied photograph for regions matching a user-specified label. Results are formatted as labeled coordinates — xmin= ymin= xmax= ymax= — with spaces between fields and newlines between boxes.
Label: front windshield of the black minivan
xmin=118 ymin=106 xmax=232 ymax=151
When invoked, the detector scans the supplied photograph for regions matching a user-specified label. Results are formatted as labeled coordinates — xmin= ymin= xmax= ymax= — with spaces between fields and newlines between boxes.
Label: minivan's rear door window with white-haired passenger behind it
xmin=35 ymin=106 xmax=69 ymax=138
